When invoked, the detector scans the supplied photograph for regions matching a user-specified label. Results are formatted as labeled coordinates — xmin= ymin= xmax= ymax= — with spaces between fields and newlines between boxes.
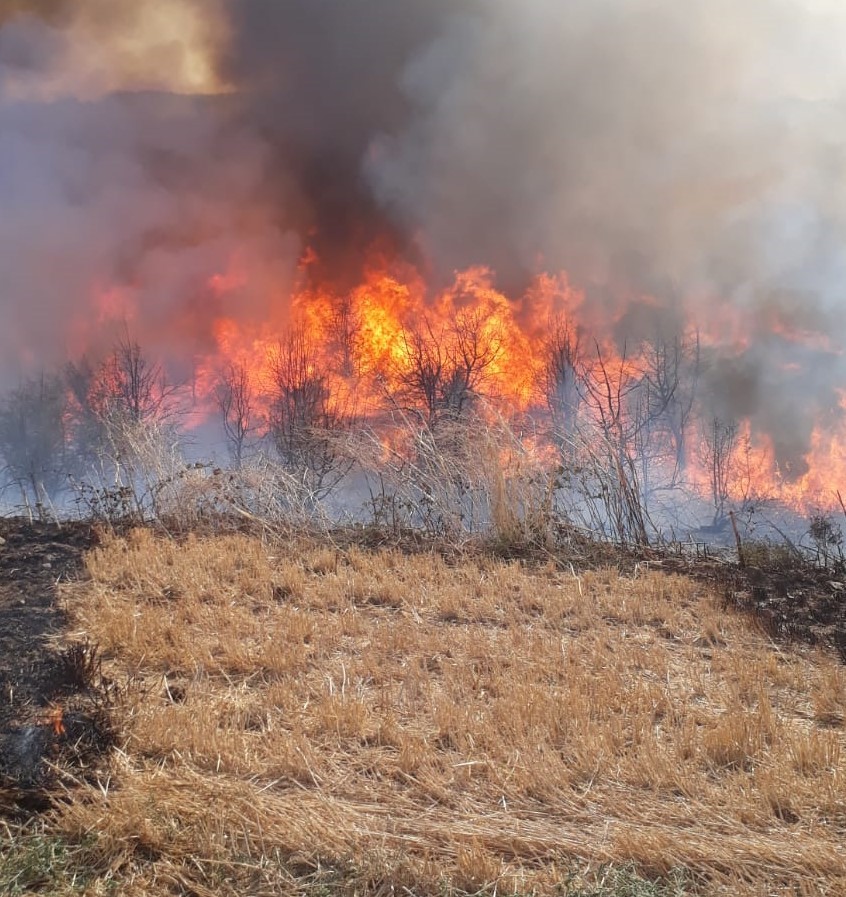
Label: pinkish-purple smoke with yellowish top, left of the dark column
xmin=0 ymin=0 xmax=300 ymax=383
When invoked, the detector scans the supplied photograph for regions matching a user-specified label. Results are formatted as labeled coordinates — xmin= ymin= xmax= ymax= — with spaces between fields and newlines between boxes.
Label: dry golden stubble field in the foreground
xmin=0 ymin=530 xmax=846 ymax=897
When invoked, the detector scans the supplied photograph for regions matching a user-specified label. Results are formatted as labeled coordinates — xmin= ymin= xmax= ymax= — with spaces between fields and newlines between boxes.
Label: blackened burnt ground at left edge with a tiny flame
xmin=0 ymin=519 xmax=117 ymax=815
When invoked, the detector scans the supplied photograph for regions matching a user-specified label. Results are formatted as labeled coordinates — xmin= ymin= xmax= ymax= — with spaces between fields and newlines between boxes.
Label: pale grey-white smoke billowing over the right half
xmin=365 ymin=0 xmax=846 ymax=472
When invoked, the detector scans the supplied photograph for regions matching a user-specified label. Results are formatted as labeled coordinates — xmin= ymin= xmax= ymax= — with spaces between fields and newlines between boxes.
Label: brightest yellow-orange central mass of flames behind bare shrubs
xmin=200 ymin=259 xmax=574 ymax=420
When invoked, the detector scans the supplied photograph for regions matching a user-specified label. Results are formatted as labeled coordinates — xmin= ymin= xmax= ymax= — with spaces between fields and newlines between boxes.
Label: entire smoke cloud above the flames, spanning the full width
xmin=0 ymin=0 xmax=846 ymax=469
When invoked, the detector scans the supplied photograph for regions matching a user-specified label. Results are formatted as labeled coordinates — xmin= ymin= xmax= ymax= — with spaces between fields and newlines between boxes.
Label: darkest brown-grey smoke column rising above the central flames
xmin=215 ymin=0 xmax=466 ymax=288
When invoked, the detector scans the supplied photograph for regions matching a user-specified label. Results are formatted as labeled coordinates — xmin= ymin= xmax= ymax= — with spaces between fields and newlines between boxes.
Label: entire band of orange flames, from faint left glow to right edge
xmin=71 ymin=238 xmax=846 ymax=510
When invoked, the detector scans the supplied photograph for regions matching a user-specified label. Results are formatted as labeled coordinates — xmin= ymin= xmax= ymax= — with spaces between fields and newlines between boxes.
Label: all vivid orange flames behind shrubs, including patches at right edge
xmin=179 ymin=238 xmax=846 ymax=517
